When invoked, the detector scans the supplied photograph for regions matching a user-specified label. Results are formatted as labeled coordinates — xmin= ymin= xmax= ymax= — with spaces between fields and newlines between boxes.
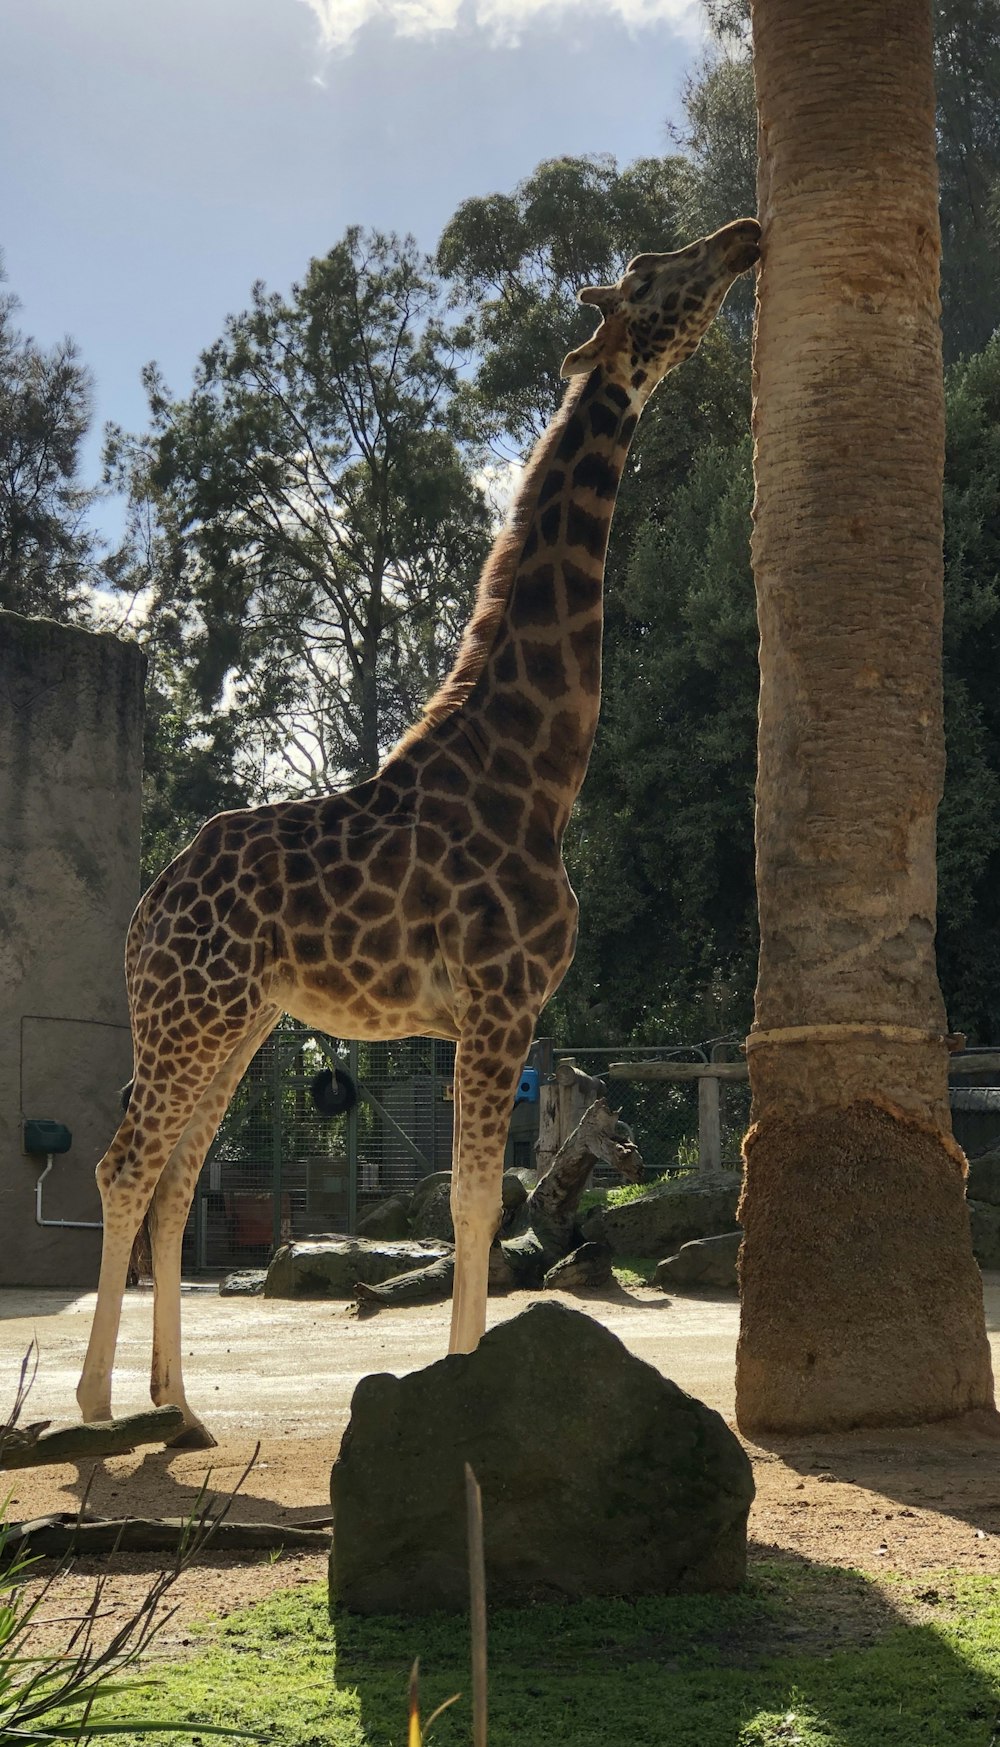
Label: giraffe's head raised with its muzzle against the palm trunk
xmin=563 ymin=218 xmax=760 ymax=400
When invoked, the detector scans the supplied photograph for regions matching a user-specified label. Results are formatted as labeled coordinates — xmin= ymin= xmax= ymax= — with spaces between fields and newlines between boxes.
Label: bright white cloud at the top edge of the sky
xmin=304 ymin=0 xmax=705 ymax=51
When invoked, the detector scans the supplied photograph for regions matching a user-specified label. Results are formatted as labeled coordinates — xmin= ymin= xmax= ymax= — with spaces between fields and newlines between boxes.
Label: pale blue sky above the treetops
xmin=0 ymin=0 xmax=705 ymax=510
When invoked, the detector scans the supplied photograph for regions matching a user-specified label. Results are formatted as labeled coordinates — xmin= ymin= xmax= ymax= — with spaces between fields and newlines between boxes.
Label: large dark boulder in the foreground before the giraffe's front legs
xmin=330 ymin=1300 xmax=753 ymax=1614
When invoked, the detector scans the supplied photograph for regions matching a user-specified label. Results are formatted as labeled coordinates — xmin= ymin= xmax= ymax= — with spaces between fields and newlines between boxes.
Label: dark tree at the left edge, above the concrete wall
xmin=0 ymin=271 xmax=94 ymax=620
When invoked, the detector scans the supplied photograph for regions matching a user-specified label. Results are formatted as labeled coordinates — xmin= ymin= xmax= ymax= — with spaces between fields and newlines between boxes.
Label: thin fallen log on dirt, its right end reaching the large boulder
xmin=0 ymin=1511 xmax=330 ymax=1565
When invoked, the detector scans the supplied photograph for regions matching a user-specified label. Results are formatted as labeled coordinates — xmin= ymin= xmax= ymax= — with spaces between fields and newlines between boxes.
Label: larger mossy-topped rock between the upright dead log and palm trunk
xmin=580 ymin=1170 xmax=741 ymax=1256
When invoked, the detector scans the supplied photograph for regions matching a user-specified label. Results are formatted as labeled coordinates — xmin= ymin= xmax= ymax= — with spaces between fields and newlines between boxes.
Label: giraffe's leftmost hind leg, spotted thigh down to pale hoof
xmin=77 ymin=1015 xmax=277 ymax=1422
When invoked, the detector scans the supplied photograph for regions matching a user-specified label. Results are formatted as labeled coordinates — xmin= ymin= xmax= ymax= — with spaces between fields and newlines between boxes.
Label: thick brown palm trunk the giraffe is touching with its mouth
xmin=736 ymin=0 xmax=993 ymax=1433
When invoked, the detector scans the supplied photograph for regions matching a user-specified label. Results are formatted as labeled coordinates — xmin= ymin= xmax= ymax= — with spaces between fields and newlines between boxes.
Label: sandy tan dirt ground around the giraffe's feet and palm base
xmin=0 ymin=1275 xmax=1000 ymax=1654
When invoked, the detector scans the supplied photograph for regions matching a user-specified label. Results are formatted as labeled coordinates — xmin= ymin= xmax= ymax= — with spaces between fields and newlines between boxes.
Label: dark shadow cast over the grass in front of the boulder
xmin=334 ymin=1555 xmax=1000 ymax=1747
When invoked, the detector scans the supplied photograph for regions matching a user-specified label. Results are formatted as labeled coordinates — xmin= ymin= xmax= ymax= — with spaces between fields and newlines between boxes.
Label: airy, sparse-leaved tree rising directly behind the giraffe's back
xmin=110 ymin=229 xmax=488 ymax=793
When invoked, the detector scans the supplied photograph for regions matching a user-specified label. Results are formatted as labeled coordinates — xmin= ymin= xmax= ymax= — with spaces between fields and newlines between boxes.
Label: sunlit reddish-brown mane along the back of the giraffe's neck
xmin=395 ymin=374 xmax=587 ymax=751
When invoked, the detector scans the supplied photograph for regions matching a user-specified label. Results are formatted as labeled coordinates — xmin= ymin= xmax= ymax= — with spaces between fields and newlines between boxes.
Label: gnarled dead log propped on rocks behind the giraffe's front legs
xmin=355 ymin=1097 xmax=643 ymax=1310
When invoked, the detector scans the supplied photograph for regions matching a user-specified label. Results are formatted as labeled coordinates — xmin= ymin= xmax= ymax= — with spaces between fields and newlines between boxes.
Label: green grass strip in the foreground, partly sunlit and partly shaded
xmin=90 ymin=1558 xmax=1000 ymax=1747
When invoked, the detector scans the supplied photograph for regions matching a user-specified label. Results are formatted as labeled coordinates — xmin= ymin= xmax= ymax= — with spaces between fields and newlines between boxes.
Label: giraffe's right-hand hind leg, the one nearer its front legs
xmin=149 ymin=1008 xmax=278 ymax=1450
